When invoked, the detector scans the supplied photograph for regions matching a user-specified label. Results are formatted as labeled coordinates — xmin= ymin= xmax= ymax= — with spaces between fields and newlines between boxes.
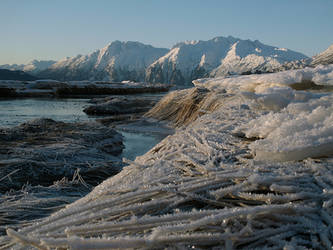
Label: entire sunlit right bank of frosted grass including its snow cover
xmin=0 ymin=65 xmax=333 ymax=249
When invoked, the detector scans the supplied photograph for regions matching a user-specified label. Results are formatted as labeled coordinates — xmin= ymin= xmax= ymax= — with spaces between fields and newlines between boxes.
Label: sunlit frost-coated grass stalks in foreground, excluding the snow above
xmin=1 ymin=89 xmax=333 ymax=249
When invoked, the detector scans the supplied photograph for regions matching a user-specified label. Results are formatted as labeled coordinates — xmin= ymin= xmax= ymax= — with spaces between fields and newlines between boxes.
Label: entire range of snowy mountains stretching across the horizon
xmin=0 ymin=36 xmax=333 ymax=85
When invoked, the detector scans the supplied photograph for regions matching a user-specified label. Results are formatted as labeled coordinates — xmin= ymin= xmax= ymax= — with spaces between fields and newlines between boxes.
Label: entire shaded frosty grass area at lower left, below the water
xmin=0 ymin=118 xmax=124 ymax=234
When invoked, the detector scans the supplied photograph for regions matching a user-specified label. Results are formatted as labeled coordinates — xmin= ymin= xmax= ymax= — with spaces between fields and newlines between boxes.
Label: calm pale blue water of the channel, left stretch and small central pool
xmin=0 ymin=99 xmax=163 ymax=160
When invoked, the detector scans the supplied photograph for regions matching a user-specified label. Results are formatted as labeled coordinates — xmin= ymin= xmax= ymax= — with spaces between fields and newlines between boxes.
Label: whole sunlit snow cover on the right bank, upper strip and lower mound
xmin=194 ymin=65 xmax=333 ymax=161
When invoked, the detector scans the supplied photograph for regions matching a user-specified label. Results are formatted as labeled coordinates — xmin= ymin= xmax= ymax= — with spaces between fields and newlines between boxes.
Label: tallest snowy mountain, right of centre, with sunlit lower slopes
xmin=146 ymin=36 xmax=307 ymax=84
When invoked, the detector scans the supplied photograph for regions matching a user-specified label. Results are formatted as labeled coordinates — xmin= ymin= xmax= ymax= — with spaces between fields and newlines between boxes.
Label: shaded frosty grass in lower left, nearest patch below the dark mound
xmin=0 ymin=170 xmax=92 ymax=234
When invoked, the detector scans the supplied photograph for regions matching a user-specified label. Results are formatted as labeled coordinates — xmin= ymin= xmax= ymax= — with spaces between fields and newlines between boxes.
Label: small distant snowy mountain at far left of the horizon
xmin=0 ymin=60 xmax=56 ymax=75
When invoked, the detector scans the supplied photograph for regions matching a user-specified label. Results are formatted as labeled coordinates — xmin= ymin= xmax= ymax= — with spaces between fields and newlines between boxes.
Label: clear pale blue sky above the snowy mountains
xmin=0 ymin=0 xmax=333 ymax=64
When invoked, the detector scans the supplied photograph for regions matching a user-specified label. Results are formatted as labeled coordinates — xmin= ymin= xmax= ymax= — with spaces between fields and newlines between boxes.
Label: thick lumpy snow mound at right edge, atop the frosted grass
xmin=236 ymin=95 xmax=333 ymax=161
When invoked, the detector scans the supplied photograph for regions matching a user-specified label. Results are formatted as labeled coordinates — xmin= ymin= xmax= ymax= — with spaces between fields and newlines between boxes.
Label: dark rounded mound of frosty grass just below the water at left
xmin=0 ymin=119 xmax=123 ymax=192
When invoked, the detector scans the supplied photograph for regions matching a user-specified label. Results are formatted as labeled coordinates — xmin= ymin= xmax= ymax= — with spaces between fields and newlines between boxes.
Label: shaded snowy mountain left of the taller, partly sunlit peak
xmin=39 ymin=41 xmax=169 ymax=81
